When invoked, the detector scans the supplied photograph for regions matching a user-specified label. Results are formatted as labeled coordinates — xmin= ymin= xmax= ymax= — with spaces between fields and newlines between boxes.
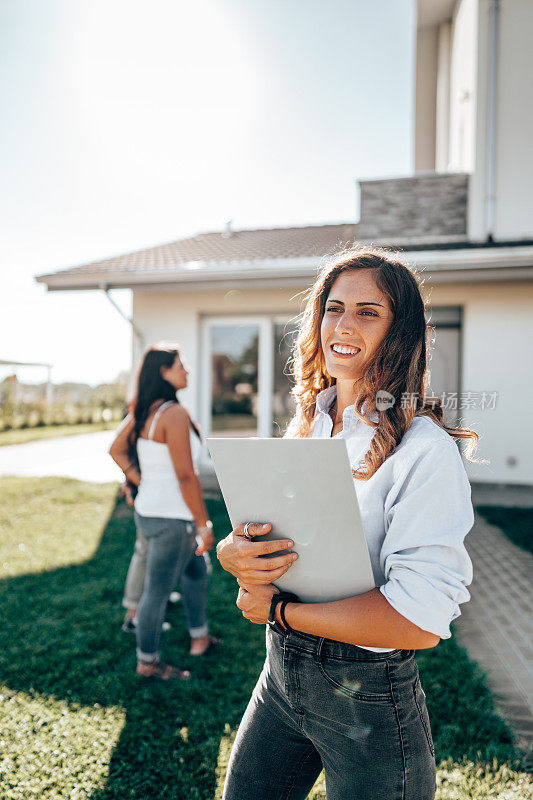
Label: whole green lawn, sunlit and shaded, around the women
xmin=0 ymin=478 xmax=533 ymax=800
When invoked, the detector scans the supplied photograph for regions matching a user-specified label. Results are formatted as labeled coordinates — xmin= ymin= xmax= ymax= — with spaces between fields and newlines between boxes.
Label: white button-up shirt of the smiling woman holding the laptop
xmin=311 ymin=386 xmax=474 ymax=652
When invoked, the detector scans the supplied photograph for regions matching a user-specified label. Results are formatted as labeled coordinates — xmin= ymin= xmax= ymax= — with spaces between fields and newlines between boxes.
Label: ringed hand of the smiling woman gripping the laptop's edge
xmin=217 ymin=522 xmax=298 ymax=586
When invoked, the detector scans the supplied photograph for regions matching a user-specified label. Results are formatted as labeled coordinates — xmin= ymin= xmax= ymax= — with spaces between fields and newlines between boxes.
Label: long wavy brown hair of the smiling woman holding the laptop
xmin=286 ymin=247 xmax=479 ymax=480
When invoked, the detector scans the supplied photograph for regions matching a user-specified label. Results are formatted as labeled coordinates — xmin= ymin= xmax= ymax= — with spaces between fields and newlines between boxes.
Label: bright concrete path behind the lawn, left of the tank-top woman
xmin=0 ymin=431 xmax=123 ymax=483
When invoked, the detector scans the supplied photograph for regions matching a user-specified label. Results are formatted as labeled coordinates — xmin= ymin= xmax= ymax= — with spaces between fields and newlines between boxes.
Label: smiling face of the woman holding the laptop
xmin=320 ymin=269 xmax=393 ymax=382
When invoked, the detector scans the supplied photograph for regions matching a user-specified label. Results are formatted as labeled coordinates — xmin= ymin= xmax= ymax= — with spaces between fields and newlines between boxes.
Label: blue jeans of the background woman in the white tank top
xmin=134 ymin=511 xmax=207 ymax=661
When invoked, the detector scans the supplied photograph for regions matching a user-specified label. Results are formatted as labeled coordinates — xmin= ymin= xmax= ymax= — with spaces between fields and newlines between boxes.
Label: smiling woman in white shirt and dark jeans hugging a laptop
xmin=217 ymin=248 xmax=478 ymax=800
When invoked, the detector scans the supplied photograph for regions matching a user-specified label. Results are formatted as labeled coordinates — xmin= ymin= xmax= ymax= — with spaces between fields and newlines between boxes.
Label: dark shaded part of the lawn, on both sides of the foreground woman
xmin=0 ymin=484 xmax=516 ymax=800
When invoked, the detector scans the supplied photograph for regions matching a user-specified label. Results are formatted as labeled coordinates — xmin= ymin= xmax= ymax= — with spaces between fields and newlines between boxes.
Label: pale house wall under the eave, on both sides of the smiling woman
xmin=133 ymin=283 xmax=533 ymax=484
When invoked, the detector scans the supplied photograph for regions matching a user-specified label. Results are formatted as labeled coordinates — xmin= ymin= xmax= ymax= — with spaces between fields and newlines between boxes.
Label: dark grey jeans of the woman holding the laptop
xmin=223 ymin=627 xmax=436 ymax=800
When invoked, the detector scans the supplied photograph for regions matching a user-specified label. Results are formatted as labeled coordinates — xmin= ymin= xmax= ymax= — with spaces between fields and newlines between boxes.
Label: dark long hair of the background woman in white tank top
xmin=129 ymin=342 xmax=202 ymax=448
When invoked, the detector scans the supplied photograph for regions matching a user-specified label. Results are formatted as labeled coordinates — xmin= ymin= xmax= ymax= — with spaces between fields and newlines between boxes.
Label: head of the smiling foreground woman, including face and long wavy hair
xmin=287 ymin=247 xmax=479 ymax=480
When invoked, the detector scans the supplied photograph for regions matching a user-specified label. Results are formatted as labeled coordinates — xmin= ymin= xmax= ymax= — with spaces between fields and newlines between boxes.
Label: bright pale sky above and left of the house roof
xmin=0 ymin=0 xmax=415 ymax=383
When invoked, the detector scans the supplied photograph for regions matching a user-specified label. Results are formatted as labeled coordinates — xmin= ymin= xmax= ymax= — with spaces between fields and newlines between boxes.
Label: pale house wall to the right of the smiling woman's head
xmin=430 ymin=283 xmax=533 ymax=485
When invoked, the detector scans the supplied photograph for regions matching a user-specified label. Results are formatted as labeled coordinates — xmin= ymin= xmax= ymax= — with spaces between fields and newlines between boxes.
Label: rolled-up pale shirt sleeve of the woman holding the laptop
xmin=379 ymin=438 xmax=474 ymax=639
